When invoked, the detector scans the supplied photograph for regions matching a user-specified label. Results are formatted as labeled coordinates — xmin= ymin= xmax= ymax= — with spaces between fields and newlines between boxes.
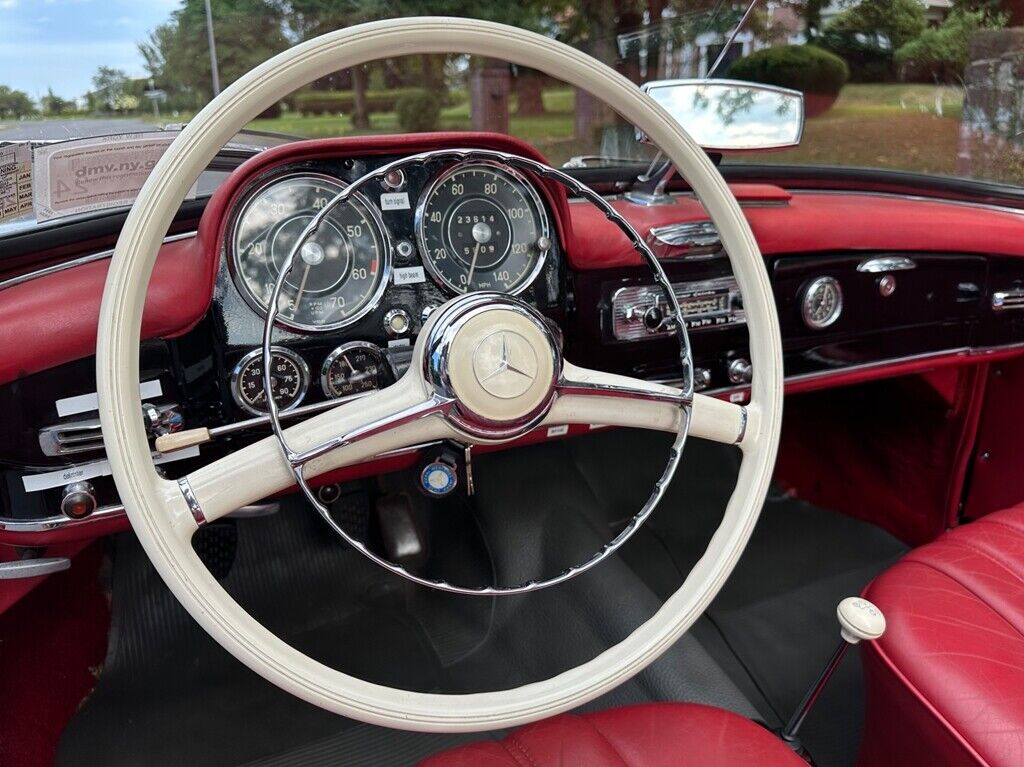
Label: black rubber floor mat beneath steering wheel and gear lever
xmin=58 ymin=430 xmax=901 ymax=767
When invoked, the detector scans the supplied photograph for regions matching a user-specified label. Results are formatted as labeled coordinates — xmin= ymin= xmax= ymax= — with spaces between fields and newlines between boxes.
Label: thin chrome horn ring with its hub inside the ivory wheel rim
xmin=262 ymin=150 xmax=693 ymax=596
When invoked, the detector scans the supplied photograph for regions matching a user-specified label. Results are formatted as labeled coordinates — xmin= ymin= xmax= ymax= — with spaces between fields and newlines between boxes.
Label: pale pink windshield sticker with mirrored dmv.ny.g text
xmin=33 ymin=131 xmax=196 ymax=221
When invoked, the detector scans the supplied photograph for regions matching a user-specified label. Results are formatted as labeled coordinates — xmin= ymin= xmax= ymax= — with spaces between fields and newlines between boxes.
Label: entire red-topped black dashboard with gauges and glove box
xmin=0 ymin=134 xmax=1024 ymax=545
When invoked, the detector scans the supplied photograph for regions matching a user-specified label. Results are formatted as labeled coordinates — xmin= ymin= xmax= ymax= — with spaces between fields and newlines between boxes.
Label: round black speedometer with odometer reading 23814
xmin=416 ymin=162 xmax=551 ymax=293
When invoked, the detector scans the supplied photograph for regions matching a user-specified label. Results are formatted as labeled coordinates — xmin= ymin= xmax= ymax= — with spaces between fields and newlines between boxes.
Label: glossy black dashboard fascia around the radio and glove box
xmin=567 ymin=253 xmax=1024 ymax=390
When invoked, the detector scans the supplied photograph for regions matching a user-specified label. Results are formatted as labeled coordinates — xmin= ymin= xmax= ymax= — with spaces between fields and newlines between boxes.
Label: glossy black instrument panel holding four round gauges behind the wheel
xmin=213 ymin=146 xmax=565 ymax=416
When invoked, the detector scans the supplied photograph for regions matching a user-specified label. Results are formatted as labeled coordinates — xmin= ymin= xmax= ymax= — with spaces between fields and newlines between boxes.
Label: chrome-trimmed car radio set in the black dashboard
xmin=611 ymin=276 xmax=746 ymax=341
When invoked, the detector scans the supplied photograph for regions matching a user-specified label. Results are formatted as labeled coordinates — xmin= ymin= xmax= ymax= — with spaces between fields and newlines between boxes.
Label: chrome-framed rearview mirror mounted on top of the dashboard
xmin=638 ymin=80 xmax=804 ymax=152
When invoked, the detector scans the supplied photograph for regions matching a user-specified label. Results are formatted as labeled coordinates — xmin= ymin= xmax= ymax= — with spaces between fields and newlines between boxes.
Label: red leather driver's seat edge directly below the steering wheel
xmin=420 ymin=704 xmax=807 ymax=767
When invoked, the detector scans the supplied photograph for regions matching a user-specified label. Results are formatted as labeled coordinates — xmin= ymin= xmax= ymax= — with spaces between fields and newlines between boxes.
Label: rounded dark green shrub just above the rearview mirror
xmin=729 ymin=45 xmax=850 ymax=95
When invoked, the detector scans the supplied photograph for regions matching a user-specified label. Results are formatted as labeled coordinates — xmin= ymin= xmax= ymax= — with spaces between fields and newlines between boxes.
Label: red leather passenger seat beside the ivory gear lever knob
xmin=860 ymin=505 xmax=1024 ymax=767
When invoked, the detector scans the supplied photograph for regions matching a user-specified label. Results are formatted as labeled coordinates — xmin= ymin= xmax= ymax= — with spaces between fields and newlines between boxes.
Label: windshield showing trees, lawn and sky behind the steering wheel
xmin=0 ymin=0 xmax=1024 ymax=184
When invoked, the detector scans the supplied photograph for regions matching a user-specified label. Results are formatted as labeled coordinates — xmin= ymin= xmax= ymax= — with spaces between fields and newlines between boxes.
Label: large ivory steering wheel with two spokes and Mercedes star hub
xmin=96 ymin=17 xmax=782 ymax=732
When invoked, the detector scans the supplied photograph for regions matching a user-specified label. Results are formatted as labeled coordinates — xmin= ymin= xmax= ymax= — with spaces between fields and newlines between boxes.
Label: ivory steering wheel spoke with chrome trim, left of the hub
xmin=165 ymin=376 xmax=454 ymax=524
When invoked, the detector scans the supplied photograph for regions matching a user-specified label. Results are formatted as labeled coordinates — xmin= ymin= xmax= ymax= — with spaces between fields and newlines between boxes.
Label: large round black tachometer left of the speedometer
xmin=231 ymin=175 xmax=390 ymax=331
